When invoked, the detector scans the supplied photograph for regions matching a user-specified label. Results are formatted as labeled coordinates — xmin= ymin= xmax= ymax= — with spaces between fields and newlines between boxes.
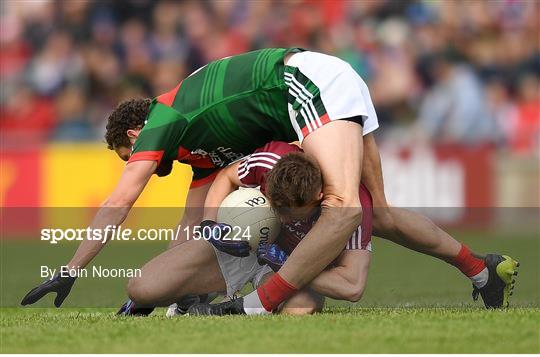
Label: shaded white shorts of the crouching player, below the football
xmin=212 ymin=246 xmax=273 ymax=296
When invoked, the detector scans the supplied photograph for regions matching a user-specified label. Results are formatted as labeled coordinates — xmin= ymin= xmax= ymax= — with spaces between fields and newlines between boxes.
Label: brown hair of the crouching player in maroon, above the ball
xmin=266 ymin=152 xmax=323 ymax=213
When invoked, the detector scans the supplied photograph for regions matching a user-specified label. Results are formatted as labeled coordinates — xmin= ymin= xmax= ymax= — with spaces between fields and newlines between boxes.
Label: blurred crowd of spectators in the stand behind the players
xmin=0 ymin=0 xmax=540 ymax=154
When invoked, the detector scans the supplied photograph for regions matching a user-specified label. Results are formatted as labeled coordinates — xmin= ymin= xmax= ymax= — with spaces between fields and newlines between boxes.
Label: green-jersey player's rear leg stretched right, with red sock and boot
xmin=362 ymin=134 xmax=519 ymax=308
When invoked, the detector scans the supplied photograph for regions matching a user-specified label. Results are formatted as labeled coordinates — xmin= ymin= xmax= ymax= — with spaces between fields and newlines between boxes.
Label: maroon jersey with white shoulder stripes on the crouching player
xmin=238 ymin=141 xmax=373 ymax=254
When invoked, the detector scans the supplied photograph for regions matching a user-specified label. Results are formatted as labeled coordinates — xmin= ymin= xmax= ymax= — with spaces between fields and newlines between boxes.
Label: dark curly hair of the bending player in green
xmin=105 ymin=98 xmax=152 ymax=150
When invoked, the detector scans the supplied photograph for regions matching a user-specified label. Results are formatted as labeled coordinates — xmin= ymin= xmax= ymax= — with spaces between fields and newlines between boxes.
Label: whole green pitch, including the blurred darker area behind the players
xmin=0 ymin=232 xmax=540 ymax=353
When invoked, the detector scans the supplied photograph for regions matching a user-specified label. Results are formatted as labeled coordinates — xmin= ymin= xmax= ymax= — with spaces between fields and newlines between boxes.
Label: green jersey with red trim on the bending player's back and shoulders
xmin=129 ymin=48 xmax=301 ymax=187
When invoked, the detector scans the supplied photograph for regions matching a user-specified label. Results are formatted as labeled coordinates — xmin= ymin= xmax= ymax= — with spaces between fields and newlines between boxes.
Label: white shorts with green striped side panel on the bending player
xmin=285 ymin=51 xmax=379 ymax=142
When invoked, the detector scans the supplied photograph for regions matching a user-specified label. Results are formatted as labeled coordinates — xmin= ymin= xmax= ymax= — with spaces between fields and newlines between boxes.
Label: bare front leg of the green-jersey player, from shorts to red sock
xmin=279 ymin=120 xmax=363 ymax=288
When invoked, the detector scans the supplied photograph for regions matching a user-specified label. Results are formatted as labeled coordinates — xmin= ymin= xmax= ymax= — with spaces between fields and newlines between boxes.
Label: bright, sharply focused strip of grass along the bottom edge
xmin=0 ymin=308 xmax=540 ymax=353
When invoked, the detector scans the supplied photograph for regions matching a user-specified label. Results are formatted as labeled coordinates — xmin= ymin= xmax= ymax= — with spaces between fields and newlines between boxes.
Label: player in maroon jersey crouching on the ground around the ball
xmin=121 ymin=142 xmax=372 ymax=315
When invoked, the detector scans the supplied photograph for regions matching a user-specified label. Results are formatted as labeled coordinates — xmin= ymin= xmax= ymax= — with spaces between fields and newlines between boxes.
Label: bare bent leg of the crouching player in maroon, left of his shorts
xmin=127 ymin=240 xmax=227 ymax=306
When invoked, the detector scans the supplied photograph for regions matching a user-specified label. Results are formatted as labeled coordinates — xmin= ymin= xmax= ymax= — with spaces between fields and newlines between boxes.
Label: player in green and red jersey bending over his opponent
xmin=22 ymin=48 xmax=517 ymax=314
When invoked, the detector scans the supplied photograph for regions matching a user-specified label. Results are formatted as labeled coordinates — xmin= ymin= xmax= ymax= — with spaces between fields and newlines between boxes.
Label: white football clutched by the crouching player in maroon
xmin=217 ymin=188 xmax=281 ymax=251
